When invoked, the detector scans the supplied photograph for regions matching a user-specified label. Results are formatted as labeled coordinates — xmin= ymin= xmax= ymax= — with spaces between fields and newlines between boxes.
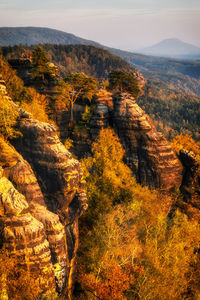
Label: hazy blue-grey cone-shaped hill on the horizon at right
xmin=137 ymin=39 xmax=200 ymax=59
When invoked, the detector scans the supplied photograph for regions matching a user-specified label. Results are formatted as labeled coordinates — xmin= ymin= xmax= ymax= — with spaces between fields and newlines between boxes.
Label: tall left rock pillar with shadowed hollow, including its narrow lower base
xmin=12 ymin=114 xmax=87 ymax=294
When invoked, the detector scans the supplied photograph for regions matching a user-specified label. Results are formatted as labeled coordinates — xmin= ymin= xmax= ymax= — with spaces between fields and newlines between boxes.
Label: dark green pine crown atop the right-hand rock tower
xmin=108 ymin=70 xmax=140 ymax=98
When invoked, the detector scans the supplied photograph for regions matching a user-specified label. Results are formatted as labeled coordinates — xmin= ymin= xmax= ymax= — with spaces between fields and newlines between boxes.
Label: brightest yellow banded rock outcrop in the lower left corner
xmin=0 ymin=172 xmax=56 ymax=292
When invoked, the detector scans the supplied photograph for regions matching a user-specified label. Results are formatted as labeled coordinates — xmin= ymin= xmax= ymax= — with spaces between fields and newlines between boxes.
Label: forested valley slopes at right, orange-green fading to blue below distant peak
xmin=110 ymin=49 xmax=200 ymax=140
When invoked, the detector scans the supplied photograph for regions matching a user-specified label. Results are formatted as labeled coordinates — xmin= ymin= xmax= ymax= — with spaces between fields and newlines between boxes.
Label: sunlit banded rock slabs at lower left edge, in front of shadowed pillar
xmin=0 ymin=140 xmax=56 ymax=291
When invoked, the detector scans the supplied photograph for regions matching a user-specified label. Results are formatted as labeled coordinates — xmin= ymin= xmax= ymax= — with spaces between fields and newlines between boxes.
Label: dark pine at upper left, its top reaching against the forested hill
xmin=32 ymin=46 xmax=55 ymax=81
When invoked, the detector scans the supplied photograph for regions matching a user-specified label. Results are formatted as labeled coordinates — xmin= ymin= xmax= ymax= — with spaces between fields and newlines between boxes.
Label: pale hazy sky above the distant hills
xmin=0 ymin=0 xmax=200 ymax=50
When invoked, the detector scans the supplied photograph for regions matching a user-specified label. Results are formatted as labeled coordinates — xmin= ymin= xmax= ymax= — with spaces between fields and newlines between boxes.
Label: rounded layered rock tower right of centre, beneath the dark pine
xmin=91 ymin=93 xmax=182 ymax=191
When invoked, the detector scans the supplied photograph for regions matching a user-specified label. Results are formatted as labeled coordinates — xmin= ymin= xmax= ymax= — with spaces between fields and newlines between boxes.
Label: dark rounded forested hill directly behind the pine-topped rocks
xmin=2 ymin=44 xmax=134 ymax=79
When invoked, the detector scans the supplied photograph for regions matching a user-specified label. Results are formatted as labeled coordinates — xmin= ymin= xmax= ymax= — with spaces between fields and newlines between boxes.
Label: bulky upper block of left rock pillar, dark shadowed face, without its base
xmin=15 ymin=114 xmax=84 ymax=213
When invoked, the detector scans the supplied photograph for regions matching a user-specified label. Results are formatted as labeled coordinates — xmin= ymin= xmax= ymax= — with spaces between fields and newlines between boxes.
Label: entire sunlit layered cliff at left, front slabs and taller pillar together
xmin=0 ymin=77 xmax=87 ymax=299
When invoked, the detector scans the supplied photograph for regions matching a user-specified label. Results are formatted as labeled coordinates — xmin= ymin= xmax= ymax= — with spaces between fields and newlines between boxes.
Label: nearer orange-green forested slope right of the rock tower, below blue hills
xmin=138 ymin=79 xmax=200 ymax=140
